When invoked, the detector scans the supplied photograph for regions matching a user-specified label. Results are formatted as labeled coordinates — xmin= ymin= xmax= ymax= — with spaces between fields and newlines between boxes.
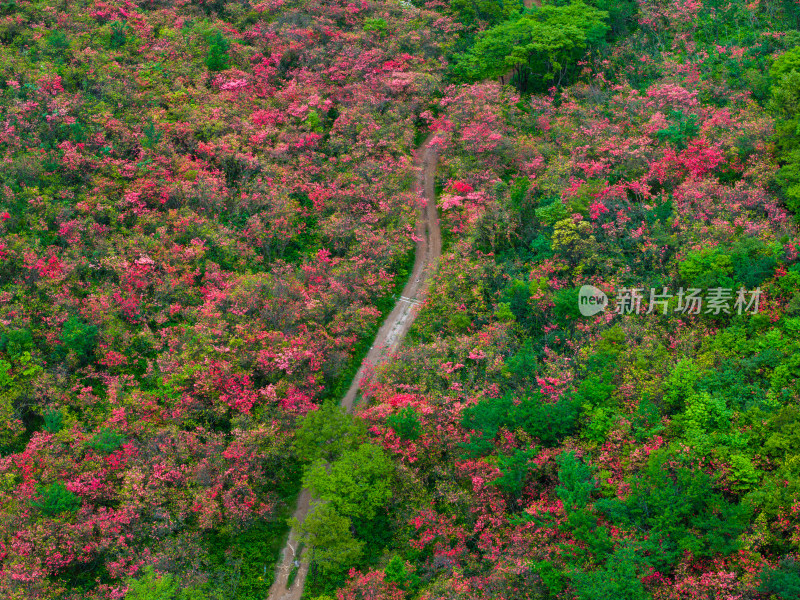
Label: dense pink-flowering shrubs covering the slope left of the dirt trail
xmin=0 ymin=0 xmax=449 ymax=599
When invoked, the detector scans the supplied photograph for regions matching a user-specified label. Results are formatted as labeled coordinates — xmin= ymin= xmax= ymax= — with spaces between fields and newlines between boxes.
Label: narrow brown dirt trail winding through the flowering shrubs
xmin=268 ymin=136 xmax=442 ymax=600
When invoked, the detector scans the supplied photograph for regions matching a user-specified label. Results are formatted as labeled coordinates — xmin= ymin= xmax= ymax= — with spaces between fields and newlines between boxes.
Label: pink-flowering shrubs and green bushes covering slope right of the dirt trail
xmin=324 ymin=1 xmax=800 ymax=600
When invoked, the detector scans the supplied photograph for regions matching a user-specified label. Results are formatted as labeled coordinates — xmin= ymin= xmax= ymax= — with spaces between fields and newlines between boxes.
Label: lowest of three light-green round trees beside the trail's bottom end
xmin=300 ymin=503 xmax=364 ymax=574
